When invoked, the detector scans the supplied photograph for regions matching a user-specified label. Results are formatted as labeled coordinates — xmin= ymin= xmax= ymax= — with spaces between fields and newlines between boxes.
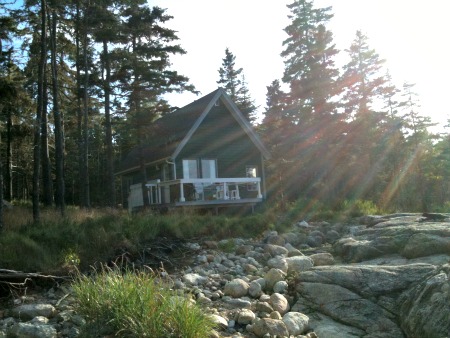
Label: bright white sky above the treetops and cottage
xmin=149 ymin=0 xmax=450 ymax=131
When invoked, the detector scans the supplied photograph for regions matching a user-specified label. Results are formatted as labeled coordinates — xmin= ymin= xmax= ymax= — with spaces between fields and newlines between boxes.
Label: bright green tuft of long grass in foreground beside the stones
xmin=73 ymin=267 xmax=214 ymax=338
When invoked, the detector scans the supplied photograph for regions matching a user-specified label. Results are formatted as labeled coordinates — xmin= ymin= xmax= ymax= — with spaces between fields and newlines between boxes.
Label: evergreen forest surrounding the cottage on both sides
xmin=0 ymin=0 xmax=450 ymax=225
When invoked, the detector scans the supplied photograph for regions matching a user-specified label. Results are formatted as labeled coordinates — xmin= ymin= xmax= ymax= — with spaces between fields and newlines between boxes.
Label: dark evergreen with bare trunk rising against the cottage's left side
xmin=117 ymin=1 xmax=194 ymax=206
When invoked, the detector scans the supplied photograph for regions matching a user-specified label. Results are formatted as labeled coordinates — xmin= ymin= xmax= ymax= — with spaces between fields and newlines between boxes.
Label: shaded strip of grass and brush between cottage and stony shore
xmin=0 ymin=207 xmax=274 ymax=274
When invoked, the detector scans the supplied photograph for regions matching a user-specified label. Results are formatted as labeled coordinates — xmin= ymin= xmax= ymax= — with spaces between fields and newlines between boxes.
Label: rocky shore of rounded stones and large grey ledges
xmin=0 ymin=214 xmax=450 ymax=338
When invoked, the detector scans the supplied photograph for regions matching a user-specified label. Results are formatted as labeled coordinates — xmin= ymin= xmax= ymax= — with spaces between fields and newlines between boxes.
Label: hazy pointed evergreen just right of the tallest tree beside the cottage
xmin=341 ymin=31 xmax=393 ymax=199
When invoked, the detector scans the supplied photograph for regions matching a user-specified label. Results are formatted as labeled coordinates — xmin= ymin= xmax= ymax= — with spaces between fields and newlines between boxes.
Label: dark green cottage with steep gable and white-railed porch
xmin=116 ymin=88 xmax=270 ymax=210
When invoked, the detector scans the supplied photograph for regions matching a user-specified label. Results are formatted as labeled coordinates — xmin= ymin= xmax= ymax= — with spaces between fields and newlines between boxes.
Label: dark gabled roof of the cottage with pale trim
xmin=116 ymin=88 xmax=270 ymax=175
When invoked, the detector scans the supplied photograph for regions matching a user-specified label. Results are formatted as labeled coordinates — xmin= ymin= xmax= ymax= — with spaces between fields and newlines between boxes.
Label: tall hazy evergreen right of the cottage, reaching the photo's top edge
xmin=281 ymin=0 xmax=342 ymax=201
